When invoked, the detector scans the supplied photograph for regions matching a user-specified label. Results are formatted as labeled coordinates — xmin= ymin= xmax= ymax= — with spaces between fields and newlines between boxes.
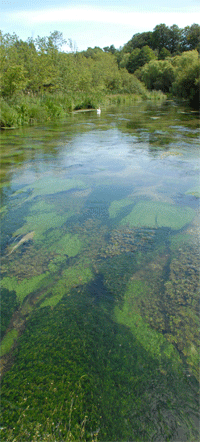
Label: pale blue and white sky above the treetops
xmin=0 ymin=0 xmax=200 ymax=51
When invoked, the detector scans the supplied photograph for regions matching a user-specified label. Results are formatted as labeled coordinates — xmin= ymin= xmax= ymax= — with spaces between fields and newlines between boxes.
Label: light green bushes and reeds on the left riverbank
xmin=0 ymin=31 xmax=152 ymax=127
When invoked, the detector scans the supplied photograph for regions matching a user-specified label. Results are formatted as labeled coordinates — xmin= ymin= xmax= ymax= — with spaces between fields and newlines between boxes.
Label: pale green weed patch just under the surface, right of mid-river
xmin=120 ymin=201 xmax=195 ymax=230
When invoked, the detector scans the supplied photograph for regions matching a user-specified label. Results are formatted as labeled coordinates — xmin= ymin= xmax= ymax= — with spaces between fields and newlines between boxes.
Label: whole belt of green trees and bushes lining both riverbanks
xmin=0 ymin=24 xmax=200 ymax=127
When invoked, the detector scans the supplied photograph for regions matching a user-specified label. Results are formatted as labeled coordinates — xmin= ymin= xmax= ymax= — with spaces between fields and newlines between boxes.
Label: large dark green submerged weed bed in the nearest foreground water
xmin=2 ymin=286 xmax=198 ymax=442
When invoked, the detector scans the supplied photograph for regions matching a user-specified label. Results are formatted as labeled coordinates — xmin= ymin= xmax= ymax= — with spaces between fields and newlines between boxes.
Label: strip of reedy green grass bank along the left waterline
xmin=0 ymin=89 xmax=167 ymax=130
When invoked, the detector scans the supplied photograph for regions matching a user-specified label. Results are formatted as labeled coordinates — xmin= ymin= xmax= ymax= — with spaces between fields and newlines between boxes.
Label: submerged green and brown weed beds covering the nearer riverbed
xmin=2 ymin=173 xmax=198 ymax=442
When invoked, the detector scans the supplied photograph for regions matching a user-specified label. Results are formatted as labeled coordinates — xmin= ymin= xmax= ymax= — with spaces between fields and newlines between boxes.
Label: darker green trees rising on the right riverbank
xmin=104 ymin=23 xmax=200 ymax=108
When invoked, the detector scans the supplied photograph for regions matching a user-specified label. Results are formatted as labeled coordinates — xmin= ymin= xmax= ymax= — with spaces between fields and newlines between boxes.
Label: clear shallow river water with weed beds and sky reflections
xmin=1 ymin=103 xmax=199 ymax=441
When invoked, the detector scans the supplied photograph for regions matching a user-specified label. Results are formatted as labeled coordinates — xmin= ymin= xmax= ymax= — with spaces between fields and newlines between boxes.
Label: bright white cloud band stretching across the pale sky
xmin=7 ymin=7 xmax=198 ymax=30
